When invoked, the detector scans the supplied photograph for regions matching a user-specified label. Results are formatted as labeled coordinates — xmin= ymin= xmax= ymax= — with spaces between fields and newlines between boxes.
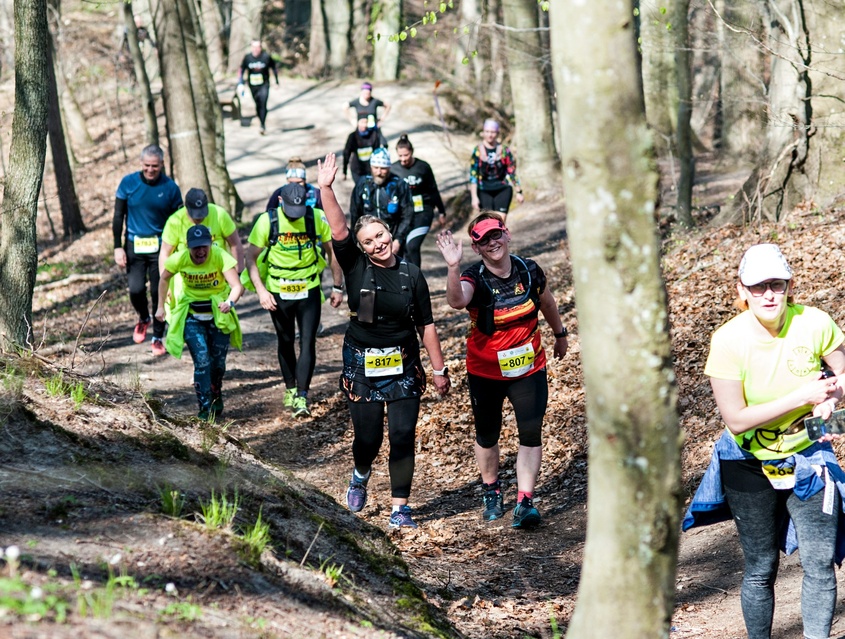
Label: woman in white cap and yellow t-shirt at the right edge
xmin=700 ymin=244 xmax=845 ymax=639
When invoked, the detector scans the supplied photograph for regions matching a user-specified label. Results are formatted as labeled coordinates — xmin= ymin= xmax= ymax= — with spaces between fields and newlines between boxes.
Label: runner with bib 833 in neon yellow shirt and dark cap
xmin=246 ymin=183 xmax=343 ymax=417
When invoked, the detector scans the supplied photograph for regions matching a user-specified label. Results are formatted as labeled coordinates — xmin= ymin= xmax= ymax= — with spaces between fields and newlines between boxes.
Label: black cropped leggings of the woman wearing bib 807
xmin=467 ymin=368 xmax=549 ymax=448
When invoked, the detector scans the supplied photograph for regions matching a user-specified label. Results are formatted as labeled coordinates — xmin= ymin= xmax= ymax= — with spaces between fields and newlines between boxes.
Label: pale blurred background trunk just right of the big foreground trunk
xmin=639 ymin=0 xmax=678 ymax=155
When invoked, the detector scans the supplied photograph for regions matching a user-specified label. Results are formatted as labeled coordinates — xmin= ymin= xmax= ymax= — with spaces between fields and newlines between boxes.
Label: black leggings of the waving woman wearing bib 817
xmin=347 ymin=397 xmax=420 ymax=499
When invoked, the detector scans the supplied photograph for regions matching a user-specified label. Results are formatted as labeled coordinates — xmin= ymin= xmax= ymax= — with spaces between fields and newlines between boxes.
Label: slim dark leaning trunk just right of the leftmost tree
xmin=47 ymin=37 xmax=85 ymax=238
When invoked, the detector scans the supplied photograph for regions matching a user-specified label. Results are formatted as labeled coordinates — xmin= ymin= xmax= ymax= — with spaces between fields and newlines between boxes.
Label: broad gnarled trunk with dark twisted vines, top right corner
xmin=713 ymin=0 xmax=845 ymax=224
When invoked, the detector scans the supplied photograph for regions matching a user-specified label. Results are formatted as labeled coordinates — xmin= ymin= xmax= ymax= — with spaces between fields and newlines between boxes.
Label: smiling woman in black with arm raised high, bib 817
xmin=318 ymin=154 xmax=451 ymax=528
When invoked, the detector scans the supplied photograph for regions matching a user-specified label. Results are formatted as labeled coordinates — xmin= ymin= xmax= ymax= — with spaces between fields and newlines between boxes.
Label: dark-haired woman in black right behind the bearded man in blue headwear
xmin=390 ymin=134 xmax=446 ymax=266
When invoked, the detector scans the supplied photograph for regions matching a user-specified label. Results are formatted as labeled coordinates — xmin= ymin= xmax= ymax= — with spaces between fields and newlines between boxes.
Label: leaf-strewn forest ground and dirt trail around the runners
xmin=0 ymin=2 xmax=845 ymax=639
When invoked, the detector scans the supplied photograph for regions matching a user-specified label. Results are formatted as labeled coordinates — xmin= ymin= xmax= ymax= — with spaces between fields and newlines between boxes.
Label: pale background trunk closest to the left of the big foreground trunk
xmin=502 ymin=0 xmax=558 ymax=192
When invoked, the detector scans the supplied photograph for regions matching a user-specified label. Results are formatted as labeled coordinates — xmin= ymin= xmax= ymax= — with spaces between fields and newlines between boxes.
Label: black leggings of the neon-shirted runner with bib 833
xmin=270 ymin=286 xmax=322 ymax=391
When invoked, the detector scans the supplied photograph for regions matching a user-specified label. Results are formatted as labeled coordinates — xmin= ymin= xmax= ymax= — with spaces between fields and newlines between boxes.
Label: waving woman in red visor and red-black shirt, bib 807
xmin=437 ymin=211 xmax=568 ymax=528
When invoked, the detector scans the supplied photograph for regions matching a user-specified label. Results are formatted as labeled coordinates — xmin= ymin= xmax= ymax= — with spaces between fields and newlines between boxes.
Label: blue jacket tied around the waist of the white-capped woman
xmin=682 ymin=430 xmax=845 ymax=565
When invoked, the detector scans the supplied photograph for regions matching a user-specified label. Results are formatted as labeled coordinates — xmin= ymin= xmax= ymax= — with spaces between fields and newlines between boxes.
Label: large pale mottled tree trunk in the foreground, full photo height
xmin=549 ymin=0 xmax=681 ymax=639
